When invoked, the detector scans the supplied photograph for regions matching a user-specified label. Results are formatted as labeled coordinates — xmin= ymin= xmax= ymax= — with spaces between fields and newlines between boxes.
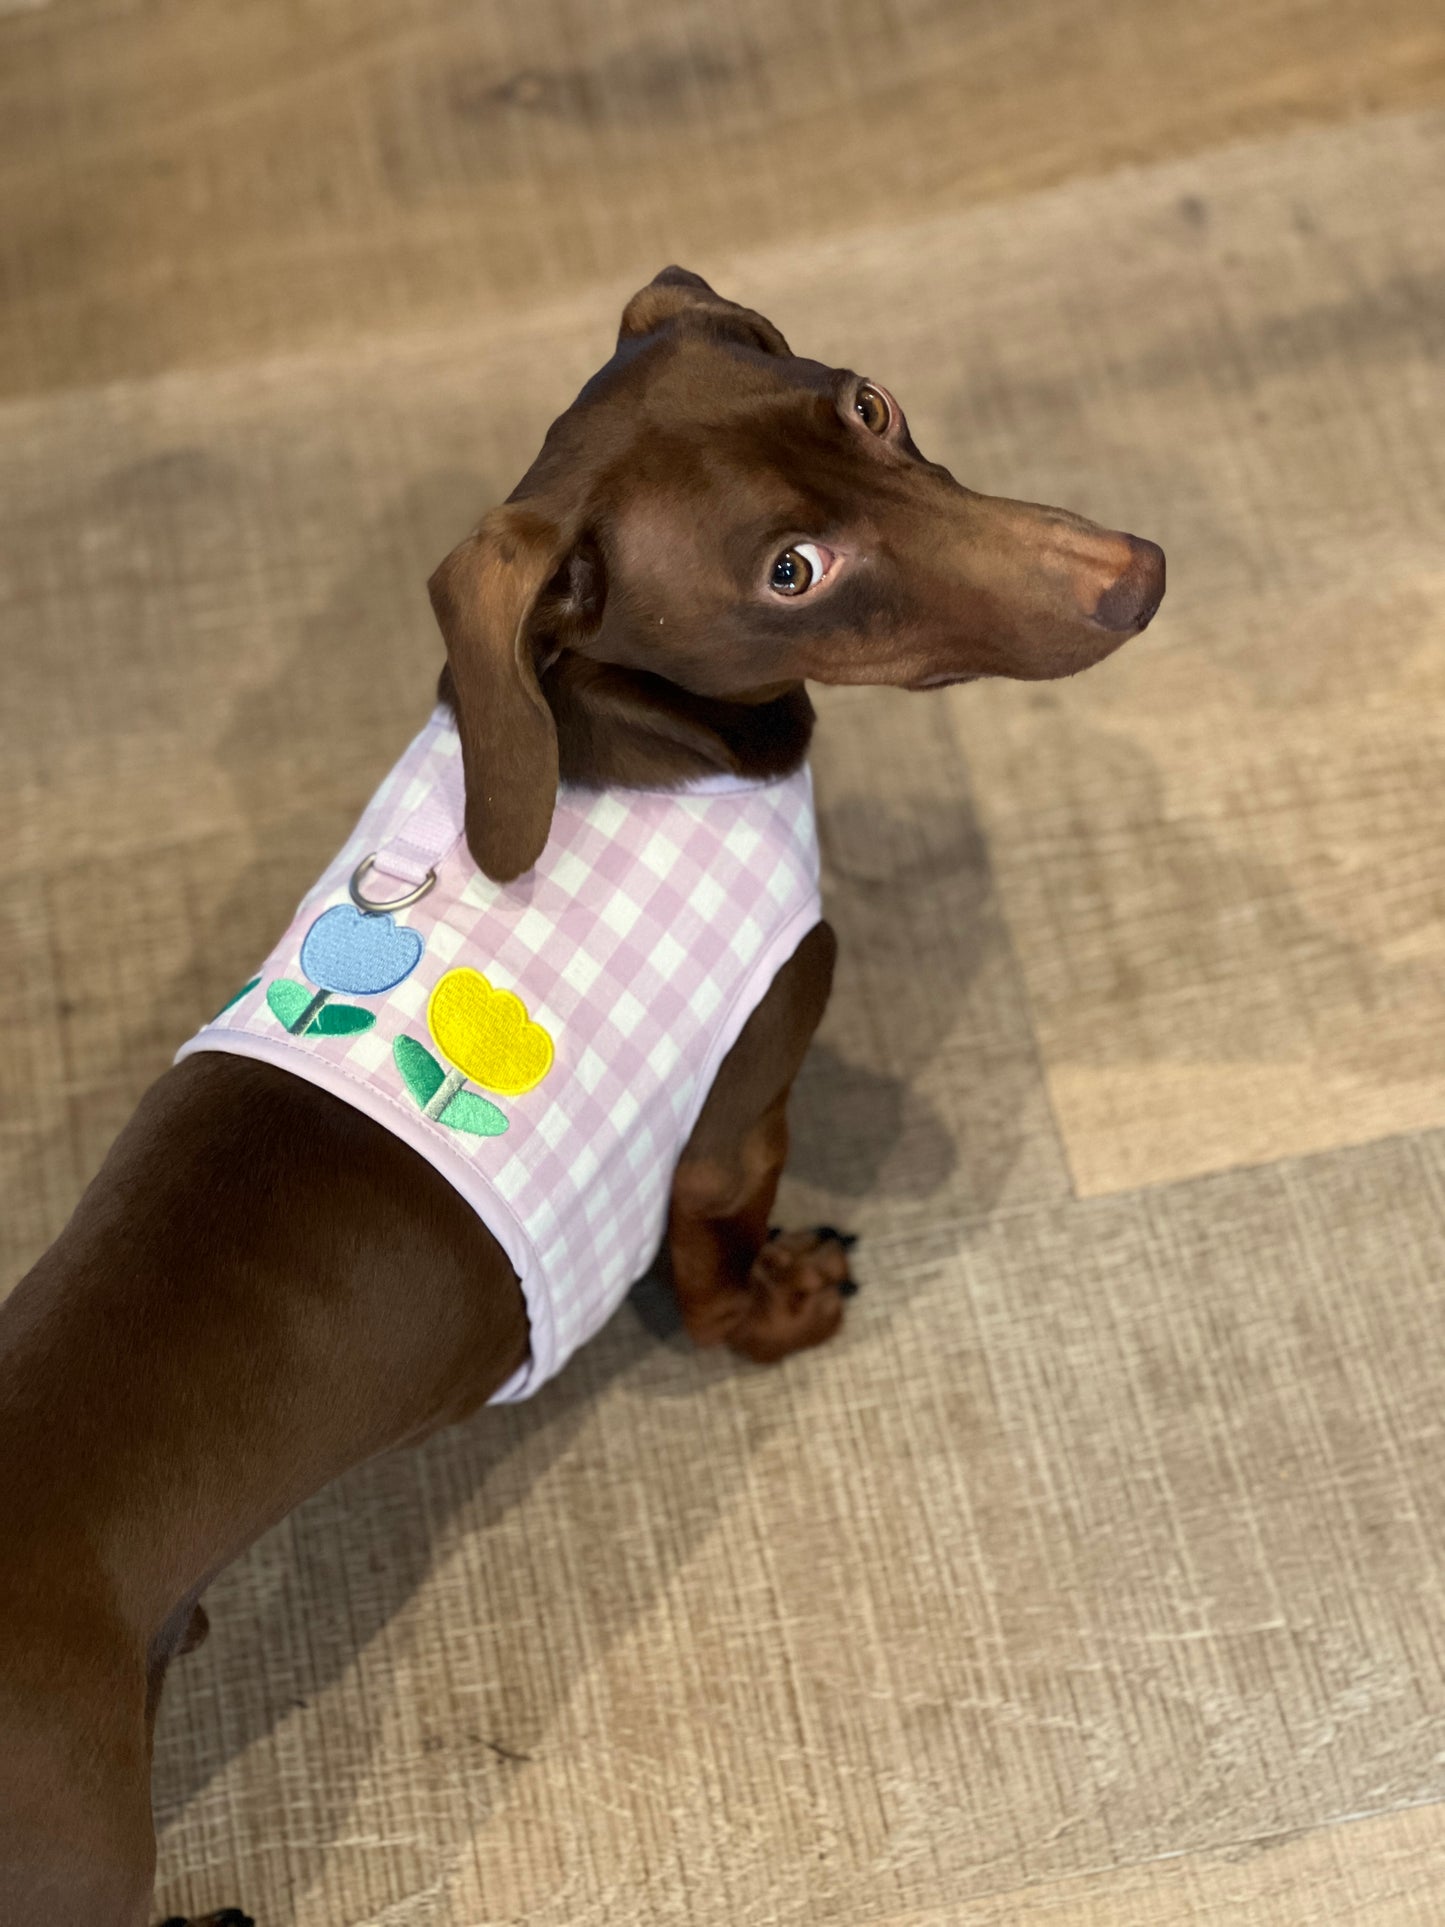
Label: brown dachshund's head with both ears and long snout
xmin=430 ymin=268 xmax=1164 ymax=881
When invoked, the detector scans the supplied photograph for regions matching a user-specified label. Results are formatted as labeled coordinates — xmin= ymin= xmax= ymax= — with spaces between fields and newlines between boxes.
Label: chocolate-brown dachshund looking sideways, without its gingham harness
xmin=0 ymin=268 xmax=1164 ymax=1927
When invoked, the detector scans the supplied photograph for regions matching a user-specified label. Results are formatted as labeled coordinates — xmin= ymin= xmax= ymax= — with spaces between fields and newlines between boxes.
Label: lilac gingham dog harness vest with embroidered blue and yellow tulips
xmin=177 ymin=707 xmax=821 ymax=1401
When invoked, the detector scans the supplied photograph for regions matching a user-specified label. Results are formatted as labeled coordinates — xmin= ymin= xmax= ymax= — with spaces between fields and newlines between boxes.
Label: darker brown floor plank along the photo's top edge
xmin=0 ymin=0 xmax=1445 ymax=393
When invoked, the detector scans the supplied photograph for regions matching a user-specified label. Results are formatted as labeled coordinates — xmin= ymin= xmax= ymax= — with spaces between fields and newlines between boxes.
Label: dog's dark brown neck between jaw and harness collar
xmin=437 ymin=649 xmax=813 ymax=790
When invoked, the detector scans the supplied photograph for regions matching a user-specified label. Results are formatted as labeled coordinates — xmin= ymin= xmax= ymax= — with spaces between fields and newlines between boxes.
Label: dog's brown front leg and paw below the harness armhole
xmin=667 ymin=923 xmax=854 ymax=1362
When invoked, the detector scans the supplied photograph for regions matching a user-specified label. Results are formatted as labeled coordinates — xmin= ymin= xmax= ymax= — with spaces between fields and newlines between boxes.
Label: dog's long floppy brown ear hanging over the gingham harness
xmin=428 ymin=505 xmax=572 ymax=883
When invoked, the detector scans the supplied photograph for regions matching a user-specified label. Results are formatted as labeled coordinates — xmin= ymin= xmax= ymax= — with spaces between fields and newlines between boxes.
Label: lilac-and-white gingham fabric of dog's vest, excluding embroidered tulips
xmin=179 ymin=709 xmax=821 ymax=1397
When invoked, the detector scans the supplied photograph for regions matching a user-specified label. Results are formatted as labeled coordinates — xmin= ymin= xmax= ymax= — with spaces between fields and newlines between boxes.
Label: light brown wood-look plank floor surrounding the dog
xmin=0 ymin=0 xmax=1445 ymax=1927
